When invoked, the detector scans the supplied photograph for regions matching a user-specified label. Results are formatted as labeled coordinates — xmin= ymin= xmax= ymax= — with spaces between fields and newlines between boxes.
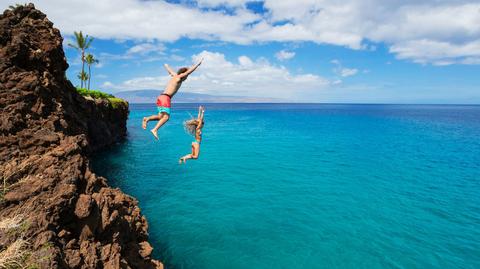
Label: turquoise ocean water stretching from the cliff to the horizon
xmin=94 ymin=104 xmax=480 ymax=269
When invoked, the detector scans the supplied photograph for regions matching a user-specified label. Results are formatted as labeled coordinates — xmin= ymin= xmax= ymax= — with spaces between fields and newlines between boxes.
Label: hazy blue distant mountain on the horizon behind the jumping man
xmin=114 ymin=90 xmax=282 ymax=103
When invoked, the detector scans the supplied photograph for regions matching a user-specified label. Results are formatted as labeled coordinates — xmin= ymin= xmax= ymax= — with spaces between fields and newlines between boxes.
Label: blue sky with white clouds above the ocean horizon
xmin=11 ymin=0 xmax=480 ymax=104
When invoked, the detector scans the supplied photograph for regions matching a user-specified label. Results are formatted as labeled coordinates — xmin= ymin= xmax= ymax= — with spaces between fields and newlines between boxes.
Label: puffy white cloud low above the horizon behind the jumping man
xmin=103 ymin=51 xmax=330 ymax=100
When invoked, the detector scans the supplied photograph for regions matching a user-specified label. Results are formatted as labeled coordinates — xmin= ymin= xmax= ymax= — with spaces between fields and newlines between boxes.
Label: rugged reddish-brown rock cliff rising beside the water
xmin=0 ymin=4 xmax=162 ymax=268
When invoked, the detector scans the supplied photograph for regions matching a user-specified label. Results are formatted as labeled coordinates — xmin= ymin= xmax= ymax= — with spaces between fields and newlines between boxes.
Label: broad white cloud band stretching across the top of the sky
xmin=20 ymin=0 xmax=480 ymax=64
